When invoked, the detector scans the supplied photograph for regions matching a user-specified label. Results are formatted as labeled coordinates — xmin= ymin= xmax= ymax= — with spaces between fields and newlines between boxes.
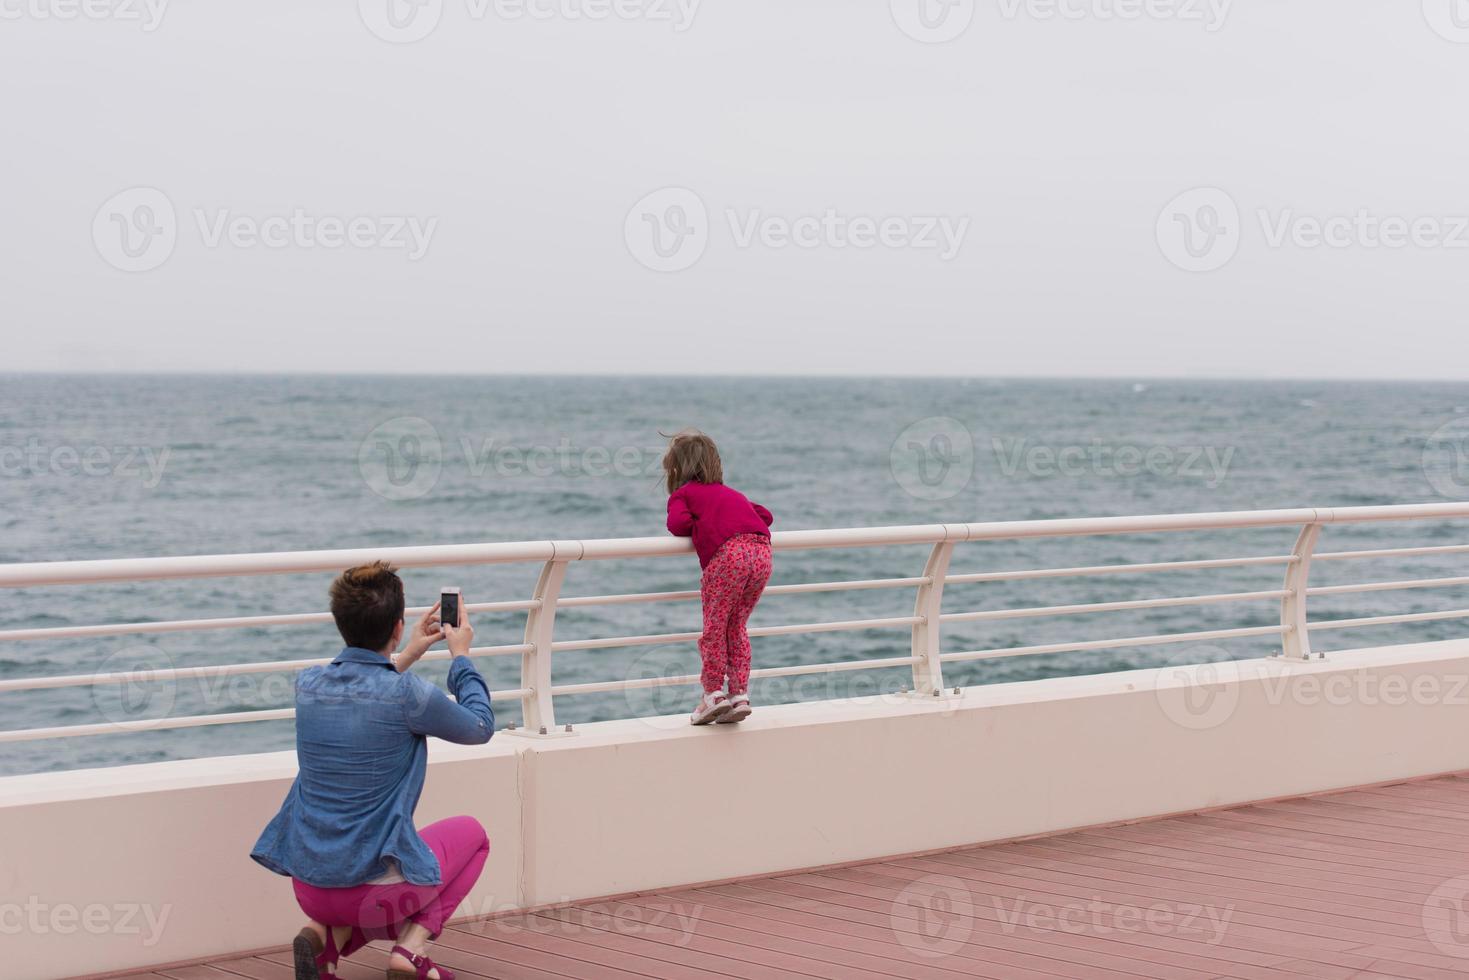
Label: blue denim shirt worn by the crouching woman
xmin=250 ymin=646 xmax=495 ymax=887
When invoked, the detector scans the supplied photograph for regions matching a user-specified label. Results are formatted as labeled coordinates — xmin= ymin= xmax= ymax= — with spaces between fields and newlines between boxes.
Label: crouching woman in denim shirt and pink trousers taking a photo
xmin=250 ymin=561 xmax=495 ymax=980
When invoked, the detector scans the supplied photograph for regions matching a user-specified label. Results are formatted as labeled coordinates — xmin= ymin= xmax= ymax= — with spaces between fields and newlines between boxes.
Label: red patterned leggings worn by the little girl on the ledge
xmin=699 ymin=535 xmax=770 ymax=695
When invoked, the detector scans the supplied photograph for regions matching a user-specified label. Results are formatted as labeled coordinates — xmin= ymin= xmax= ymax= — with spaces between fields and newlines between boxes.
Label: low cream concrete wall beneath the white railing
xmin=0 ymin=641 xmax=1469 ymax=980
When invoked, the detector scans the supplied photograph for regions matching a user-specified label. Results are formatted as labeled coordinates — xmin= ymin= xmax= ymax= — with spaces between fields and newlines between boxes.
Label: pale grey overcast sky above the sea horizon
xmin=0 ymin=0 xmax=1469 ymax=379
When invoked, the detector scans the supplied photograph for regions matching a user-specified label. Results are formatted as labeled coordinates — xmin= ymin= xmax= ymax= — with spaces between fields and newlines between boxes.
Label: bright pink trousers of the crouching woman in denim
xmin=292 ymin=817 xmax=489 ymax=940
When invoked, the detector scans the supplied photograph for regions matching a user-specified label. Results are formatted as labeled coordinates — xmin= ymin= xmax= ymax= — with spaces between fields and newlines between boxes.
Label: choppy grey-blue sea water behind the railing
xmin=0 ymin=376 xmax=1469 ymax=773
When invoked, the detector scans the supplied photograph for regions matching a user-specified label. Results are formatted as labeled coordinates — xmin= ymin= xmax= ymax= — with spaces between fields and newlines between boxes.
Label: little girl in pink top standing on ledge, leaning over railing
xmin=663 ymin=432 xmax=773 ymax=724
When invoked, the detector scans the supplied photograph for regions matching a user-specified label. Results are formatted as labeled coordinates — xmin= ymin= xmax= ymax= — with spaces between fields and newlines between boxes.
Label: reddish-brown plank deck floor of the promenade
xmin=117 ymin=777 xmax=1469 ymax=980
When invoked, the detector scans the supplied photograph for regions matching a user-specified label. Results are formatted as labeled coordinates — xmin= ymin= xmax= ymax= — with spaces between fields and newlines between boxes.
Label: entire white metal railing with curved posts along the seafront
xmin=0 ymin=504 xmax=1469 ymax=743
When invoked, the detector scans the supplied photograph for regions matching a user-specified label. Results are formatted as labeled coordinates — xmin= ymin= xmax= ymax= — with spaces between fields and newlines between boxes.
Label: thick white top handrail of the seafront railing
xmin=0 ymin=502 xmax=1469 ymax=588
